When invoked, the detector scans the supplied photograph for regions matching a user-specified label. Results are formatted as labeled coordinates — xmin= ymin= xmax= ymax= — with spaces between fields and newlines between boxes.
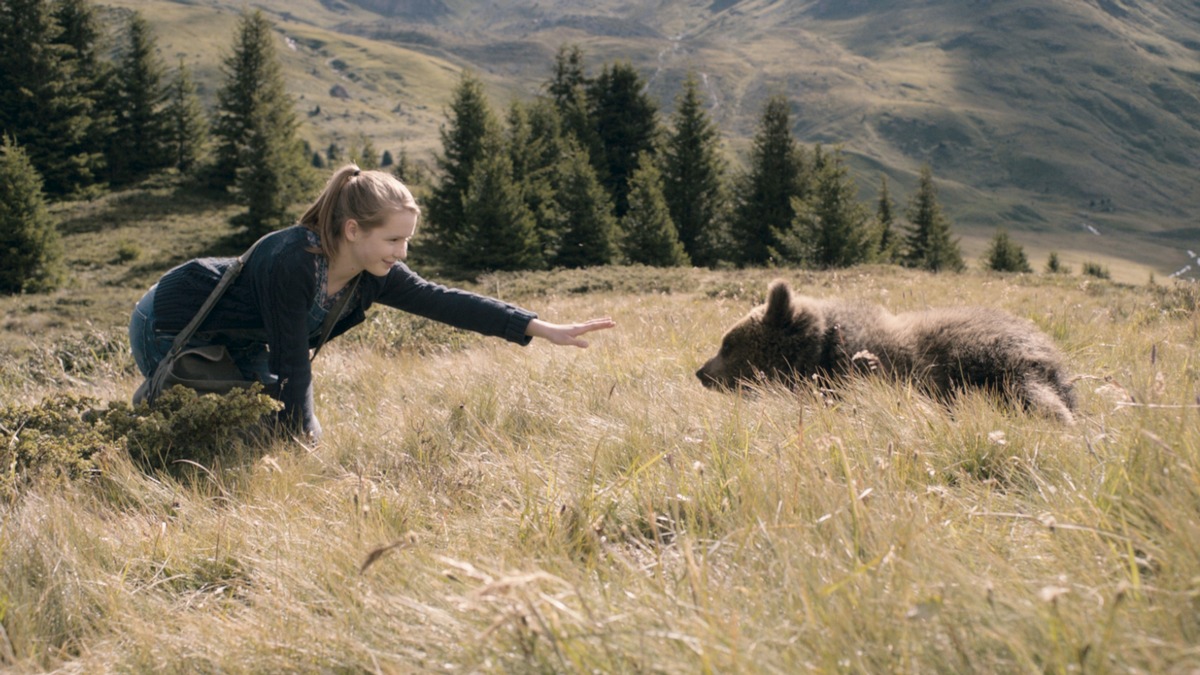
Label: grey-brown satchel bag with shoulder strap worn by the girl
xmin=133 ymin=237 xmax=359 ymax=405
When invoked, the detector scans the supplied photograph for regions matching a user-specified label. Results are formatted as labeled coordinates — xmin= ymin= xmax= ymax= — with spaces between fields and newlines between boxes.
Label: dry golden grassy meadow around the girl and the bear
xmin=0 ymin=172 xmax=1200 ymax=673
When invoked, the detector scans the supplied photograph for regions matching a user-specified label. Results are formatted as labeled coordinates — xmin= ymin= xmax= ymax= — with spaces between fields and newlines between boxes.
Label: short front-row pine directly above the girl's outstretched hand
xmin=552 ymin=141 xmax=617 ymax=268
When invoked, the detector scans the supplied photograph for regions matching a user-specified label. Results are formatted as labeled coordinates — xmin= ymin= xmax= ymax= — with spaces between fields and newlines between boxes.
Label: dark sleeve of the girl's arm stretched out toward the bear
xmin=376 ymin=263 xmax=538 ymax=345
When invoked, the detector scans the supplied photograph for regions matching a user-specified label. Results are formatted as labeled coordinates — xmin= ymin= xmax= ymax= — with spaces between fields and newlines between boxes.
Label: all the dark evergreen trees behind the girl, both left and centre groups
xmin=0 ymin=0 xmax=1041 ymax=293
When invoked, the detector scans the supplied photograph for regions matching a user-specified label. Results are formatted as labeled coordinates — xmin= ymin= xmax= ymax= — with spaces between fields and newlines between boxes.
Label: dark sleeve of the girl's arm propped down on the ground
xmin=254 ymin=250 xmax=320 ymax=435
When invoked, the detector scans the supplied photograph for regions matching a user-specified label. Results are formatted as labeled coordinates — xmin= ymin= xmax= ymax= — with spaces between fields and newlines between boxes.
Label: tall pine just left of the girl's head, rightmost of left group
xmin=211 ymin=10 xmax=307 ymax=192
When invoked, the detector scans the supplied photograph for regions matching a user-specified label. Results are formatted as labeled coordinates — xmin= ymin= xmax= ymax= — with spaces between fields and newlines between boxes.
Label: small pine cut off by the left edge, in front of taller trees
xmin=0 ymin=135 xmax=66 ymax=294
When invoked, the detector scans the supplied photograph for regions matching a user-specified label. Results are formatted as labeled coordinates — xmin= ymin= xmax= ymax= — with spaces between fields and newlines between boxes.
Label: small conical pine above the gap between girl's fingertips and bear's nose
xmin=620 ymin=153 xmax=691 ymax=267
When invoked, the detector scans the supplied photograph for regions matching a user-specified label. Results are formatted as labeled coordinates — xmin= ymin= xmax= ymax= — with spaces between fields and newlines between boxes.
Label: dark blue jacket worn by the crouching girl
xmin=154 ymin=226 xmax=538 ymax=431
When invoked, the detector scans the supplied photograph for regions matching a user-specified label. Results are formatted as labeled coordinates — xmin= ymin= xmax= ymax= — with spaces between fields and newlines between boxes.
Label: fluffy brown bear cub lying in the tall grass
xmin=696 ymin=280 xmax=1075 ymax=424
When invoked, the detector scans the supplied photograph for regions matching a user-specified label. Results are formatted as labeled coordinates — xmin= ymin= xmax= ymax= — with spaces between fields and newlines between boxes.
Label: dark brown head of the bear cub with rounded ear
xmin=696 ymin=280 xmax=823 ymax=389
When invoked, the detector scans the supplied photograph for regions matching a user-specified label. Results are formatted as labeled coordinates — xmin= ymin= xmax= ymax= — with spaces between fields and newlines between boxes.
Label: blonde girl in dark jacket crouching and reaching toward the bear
xmin=130 ymin=165 xmax=616 ymax=441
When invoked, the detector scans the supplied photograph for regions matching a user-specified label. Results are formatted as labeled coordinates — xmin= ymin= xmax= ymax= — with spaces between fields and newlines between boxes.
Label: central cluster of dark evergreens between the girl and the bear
xmin=422 ymin=46 xmax=964 ymax=271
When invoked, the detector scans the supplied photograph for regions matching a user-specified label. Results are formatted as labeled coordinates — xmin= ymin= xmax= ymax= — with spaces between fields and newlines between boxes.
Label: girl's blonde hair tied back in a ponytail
xmin=300 ymin=165 xmax=421 ymax=259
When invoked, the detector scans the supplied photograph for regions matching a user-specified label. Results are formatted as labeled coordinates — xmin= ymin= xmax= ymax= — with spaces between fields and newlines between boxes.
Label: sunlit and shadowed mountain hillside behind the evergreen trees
xmin=103 ymin=0 xmax=1200 ymax=281
